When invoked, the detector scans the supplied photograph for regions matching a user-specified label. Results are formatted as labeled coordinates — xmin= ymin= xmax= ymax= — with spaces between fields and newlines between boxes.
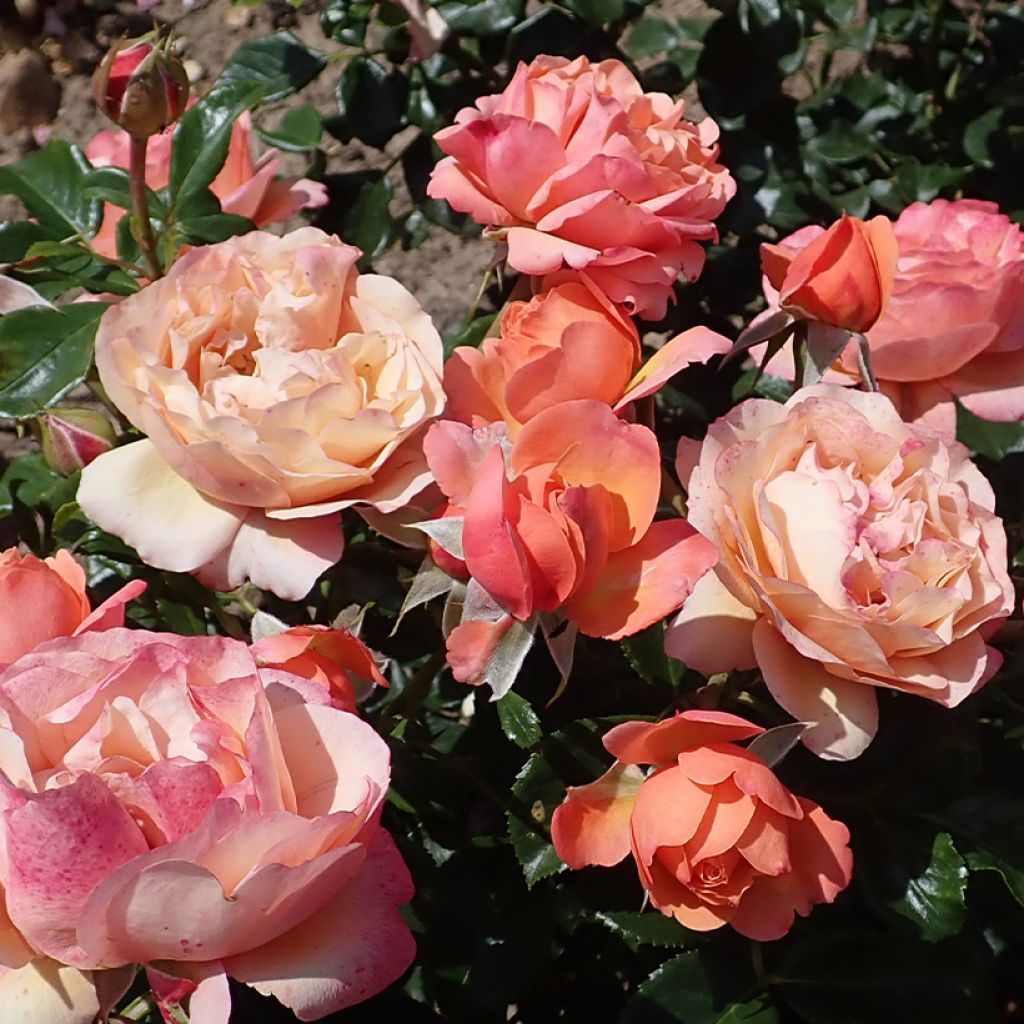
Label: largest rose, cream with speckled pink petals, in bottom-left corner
xmin=0 ymin=629 xmax=414 ymax=1024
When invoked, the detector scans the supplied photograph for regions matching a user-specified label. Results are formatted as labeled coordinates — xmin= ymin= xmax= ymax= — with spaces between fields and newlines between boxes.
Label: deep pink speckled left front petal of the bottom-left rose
xmin=3 ymin=774 xmax=148 ymax=967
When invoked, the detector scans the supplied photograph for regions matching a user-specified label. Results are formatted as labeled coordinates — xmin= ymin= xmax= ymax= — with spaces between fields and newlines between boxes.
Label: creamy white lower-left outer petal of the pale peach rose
xmin=78 ymin=440 xmax=249 ymax=572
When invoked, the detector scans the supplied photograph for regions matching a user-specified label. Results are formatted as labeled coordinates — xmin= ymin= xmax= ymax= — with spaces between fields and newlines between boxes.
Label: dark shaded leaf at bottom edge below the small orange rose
xmin=621 ymin=950 xmax=778 ymax=1024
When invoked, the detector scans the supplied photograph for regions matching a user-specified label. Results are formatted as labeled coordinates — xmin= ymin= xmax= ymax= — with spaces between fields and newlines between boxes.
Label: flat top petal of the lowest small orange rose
xmin=602 ymin=711 xmax=764 ymax=778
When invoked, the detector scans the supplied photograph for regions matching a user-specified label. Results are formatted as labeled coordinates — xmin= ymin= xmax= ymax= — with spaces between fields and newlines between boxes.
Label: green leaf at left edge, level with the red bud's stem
xmin=0 ymin=138 xmax=101 ymax=239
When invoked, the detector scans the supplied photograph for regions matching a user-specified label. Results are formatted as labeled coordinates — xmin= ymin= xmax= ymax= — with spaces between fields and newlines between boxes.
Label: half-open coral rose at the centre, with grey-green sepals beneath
xmin=424 ymin=399 xmax=716 ymax=643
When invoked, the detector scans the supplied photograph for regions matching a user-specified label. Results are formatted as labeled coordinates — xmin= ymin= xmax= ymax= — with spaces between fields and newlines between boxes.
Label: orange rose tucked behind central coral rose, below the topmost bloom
xmin=444 ymin=274 xmax=730 ymax=435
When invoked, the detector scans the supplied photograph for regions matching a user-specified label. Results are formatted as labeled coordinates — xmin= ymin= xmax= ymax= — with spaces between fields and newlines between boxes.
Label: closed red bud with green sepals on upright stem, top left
xmin=92 ymin=39 xmax=188 ymax=138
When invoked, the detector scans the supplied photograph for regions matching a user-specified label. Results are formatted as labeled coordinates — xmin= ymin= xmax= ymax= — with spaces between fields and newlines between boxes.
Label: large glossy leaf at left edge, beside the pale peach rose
xmin=0 ymin=302 xmax=106 ymax=420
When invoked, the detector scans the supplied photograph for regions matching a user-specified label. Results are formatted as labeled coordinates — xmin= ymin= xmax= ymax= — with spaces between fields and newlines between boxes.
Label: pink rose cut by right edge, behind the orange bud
xmin=765 ymin=199 xmax=1024 ymax=436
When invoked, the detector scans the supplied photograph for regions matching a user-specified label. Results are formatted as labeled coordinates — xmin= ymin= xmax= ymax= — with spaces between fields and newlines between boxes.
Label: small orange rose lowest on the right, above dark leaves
xmin=551 ymin=711 xmax=853 ymax=941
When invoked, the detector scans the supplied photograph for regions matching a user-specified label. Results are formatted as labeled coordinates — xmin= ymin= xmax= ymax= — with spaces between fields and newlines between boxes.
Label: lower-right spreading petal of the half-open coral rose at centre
xmin=564 ymin=519 xmax=718 ymax=640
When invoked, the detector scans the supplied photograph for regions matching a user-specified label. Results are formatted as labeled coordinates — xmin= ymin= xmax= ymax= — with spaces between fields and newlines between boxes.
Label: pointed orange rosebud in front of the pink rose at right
xmin=761 ymin=213 xmax=899 ymax=334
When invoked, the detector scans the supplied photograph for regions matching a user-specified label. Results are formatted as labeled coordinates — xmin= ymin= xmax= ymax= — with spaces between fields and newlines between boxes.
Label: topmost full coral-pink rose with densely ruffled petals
xmin=427 ymin=56 xmax=736 ymax=319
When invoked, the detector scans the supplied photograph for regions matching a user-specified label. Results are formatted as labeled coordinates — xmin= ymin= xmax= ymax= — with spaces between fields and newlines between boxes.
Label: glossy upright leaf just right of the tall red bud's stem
xmin=170 ymin=81 xmax=264 ymax=205
